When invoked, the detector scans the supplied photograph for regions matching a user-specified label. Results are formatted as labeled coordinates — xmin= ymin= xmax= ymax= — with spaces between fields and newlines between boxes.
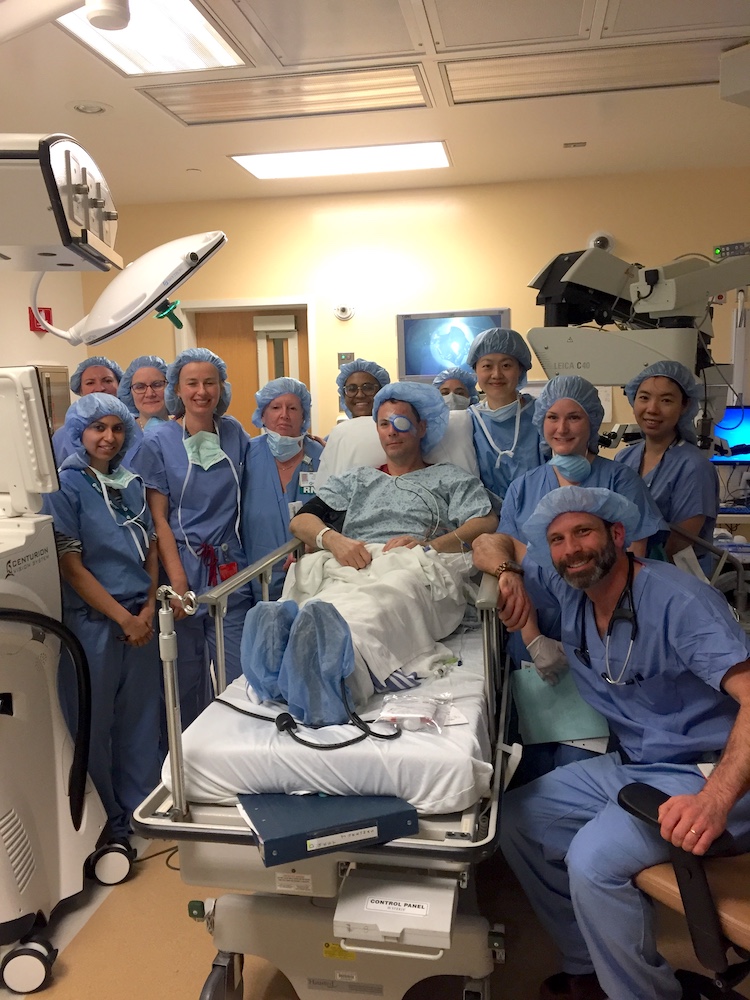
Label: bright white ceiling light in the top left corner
xmin=58 ymin=0 xmax=244 ymax=76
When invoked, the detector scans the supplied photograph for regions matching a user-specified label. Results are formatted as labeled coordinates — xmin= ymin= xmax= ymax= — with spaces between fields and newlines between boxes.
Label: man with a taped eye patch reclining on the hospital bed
xmin=243 ymin=383 xmax=497 ymax=724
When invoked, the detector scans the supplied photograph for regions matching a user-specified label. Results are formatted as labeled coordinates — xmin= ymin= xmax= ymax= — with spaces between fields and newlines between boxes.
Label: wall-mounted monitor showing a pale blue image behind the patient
xmin=396 ymin=308 xmax=510 ymax=382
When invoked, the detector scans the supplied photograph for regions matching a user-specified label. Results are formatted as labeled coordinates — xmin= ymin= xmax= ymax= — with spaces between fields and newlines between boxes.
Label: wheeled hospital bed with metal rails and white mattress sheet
xmin=133 ymin=542 xmax=520 ymax=1000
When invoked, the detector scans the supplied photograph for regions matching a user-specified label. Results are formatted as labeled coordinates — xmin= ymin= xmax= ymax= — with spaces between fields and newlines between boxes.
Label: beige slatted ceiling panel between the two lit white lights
xmin=143 ymin=66 xmax=428 ymax=125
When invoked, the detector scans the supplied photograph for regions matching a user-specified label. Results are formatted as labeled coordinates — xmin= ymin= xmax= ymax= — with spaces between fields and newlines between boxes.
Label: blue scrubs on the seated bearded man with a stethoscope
xmin=502 ymin=559 xmax=750 ymax=1000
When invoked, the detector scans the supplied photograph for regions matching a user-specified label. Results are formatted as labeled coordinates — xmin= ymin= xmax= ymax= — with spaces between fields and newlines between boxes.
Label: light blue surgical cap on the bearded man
xmin=523 ymin=486 xmax=640 ymax=567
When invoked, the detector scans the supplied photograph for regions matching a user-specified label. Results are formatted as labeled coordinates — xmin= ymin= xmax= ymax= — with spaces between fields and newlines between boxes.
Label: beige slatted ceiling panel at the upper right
xmin=443 ymin=41 xmax=721 ymax=104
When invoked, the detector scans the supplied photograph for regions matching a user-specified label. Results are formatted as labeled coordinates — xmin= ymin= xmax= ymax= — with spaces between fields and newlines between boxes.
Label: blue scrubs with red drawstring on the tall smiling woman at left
xmin=130 ymin=417 xmax=253 ymax=727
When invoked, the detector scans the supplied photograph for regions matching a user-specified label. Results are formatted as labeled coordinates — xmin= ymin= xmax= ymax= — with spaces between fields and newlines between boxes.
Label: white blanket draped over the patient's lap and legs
xmin=282 ymin=545 xmax=471 ymax=704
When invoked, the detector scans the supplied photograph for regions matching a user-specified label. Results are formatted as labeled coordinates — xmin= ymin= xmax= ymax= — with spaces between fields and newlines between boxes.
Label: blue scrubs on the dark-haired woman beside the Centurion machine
xmin=43 ymin=469 xmax=160 ymax=837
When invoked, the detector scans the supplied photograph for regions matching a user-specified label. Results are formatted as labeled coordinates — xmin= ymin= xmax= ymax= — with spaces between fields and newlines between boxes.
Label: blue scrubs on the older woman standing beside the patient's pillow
xmin=241 ymin=435 xmax=323 ymax=601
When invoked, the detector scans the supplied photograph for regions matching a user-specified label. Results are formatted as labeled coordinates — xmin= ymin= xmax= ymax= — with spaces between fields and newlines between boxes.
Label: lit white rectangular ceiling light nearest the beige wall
xmin=232 ymin=142 xmax=450 ymax=180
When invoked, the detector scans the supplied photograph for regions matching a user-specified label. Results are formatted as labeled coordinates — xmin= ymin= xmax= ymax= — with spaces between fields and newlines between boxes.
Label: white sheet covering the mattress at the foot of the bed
xmin=162 ymin=629 xmax=492 ymax=815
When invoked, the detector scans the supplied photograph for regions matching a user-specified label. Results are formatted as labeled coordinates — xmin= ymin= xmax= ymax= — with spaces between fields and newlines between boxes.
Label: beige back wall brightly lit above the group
xmin=83 ymin=166 xmax=750 ymax=433
